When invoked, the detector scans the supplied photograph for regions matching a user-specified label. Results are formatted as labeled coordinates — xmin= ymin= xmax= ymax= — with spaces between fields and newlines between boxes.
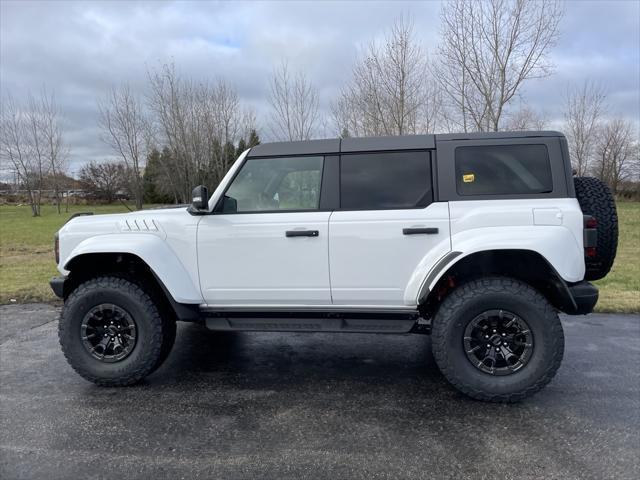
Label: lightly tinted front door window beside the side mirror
xmin=225 ymin=157 xmax=323 ymax=212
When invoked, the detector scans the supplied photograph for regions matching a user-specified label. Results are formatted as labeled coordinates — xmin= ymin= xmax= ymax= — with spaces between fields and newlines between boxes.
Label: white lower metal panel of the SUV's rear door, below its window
xmin=329 ymin=203 xmax=451 ymax=306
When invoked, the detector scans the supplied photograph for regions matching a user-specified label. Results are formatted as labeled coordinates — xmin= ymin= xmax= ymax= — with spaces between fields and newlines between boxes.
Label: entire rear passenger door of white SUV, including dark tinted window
xmin=329 ymin=151 xmax=450 ymax=306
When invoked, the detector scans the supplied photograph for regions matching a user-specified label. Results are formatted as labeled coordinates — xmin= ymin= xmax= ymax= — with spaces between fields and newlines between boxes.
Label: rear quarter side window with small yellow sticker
xmin=455 ymin=145 xmax=553 ymax=195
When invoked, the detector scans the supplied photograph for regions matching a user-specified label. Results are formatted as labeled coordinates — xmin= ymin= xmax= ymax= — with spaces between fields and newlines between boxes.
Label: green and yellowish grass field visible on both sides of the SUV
xmin=0 ymin=202 xmax=640 ymax=312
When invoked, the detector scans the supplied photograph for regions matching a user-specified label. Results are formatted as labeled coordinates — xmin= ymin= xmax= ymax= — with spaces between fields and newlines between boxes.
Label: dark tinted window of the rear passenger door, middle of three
xmin=340 ymin=152 xmax=432 ymax=210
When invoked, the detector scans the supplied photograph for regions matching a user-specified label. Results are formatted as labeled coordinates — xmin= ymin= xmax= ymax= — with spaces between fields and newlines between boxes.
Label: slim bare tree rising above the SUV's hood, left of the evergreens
xmin=98 ymin=84 xmax=149 ymax=209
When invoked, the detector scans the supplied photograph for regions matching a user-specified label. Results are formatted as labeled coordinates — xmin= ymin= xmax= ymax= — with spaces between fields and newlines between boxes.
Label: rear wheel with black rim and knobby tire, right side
xmin=432 ymin=277 xmax=564 ymax=402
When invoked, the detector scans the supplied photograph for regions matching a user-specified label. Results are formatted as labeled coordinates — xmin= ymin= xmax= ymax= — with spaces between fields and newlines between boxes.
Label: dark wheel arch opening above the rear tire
xmin=418 ymin=249 xmax=577 ymax=316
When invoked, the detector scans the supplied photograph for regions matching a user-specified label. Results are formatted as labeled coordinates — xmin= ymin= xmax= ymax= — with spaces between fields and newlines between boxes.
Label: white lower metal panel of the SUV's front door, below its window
xmin=198 ymin=212 xmax=331 ymax=305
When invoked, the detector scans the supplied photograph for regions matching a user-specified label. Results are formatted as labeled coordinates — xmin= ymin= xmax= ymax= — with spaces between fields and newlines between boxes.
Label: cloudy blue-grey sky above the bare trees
xmin=0 ymin=0 xmax=640 ymax=173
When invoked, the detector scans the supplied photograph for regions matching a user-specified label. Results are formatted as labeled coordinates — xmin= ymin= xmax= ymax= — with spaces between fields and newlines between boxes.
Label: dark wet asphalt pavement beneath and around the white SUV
xmin=0 ymin=305 xmax=640 ymax=480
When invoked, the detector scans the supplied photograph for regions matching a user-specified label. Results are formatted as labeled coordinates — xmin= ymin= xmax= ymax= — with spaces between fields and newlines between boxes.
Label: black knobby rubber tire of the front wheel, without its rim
xmin=58 ymin=276 xmax=168 ymax=387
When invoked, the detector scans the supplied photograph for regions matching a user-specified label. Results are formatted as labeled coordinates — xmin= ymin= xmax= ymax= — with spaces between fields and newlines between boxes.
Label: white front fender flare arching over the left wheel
xmin=60 ymin=233 xmax=204 ymax=304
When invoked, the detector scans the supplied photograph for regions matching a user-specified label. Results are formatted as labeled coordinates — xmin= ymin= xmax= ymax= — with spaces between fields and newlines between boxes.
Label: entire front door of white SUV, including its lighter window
xmin=198 ymin=156 xmax=331 ymax=306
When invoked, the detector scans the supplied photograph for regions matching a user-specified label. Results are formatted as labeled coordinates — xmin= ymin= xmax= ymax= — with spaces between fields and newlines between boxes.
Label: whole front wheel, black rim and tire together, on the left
xmin=58 ymin=276 xmax=170 ymax=386
